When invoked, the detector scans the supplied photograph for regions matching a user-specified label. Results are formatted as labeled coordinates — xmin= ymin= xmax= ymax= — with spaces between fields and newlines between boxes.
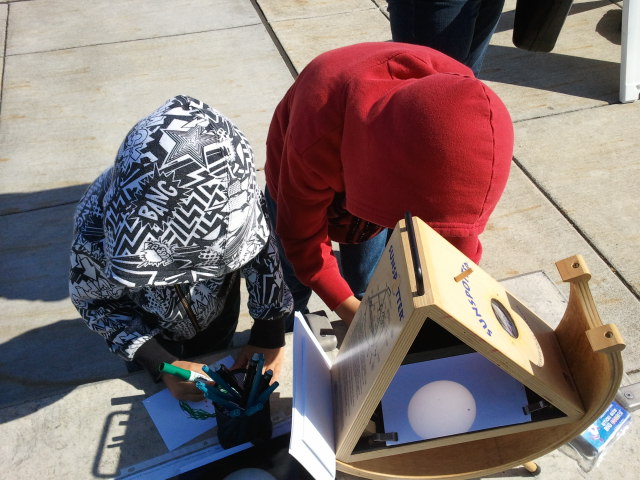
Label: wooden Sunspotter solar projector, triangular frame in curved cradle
xmin=331 ymin=215 xmax=624 ymax=480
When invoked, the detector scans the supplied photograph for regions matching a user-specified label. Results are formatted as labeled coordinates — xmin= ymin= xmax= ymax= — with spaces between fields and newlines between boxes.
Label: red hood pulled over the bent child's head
xmin=341 ymin=43 xmax=513 ymax=261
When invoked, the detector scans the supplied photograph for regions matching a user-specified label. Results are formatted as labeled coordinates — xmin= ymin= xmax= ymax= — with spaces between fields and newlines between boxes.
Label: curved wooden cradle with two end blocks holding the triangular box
xmin=337 ymin=255 xmax=625 ymax=480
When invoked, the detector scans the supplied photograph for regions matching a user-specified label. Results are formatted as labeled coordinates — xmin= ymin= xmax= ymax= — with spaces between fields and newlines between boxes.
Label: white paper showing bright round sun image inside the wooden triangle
xmin=381 ymin=352 xmax=531 ymax=446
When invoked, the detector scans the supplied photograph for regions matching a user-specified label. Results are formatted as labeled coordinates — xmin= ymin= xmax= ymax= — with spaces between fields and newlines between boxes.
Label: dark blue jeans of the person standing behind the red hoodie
xmin=388 ymin=0 xmax=504 ymax=76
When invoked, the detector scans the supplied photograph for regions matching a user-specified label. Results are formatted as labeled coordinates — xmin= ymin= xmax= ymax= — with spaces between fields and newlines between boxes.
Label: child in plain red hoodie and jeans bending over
xmin=266 ymin=42 xmax=513 ymax=324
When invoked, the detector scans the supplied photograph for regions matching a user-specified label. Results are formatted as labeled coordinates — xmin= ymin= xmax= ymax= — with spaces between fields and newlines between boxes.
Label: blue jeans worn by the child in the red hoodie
xmin=264 ymin=188 xmax=391 ymax=332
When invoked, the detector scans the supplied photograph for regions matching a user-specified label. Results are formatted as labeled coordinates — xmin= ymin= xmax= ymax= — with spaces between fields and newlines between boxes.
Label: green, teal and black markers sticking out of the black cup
xmin=159 ymin=353 xmax=278 ymax=416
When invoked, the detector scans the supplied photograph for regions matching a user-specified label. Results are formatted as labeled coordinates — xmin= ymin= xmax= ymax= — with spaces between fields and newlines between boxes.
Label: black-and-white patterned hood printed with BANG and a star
xmin=102 ymin=95 xmax=269 ymax=287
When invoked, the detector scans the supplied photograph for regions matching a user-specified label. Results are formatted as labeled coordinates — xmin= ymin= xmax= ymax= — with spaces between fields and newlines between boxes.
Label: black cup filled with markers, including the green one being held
xmin=160 ymin=353 xmax=278 ymax=448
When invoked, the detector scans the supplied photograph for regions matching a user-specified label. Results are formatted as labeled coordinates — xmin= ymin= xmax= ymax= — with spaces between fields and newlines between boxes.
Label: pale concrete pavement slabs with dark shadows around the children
xmin=0 ymin=0 xmax=640 ymax=480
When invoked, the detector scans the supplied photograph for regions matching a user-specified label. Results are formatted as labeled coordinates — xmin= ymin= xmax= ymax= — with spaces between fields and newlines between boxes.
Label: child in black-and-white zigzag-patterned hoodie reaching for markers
xmin=70 ymin=96 xmax=292 ymax=400
